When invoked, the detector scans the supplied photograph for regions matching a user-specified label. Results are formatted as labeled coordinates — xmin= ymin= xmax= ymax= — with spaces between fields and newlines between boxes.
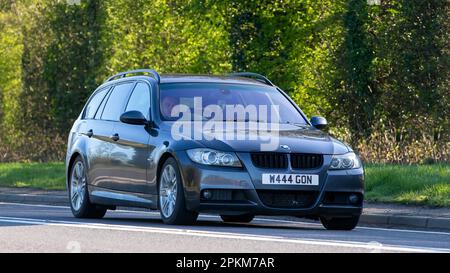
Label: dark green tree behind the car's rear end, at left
xmin=43 ymin=0 xmax=105 ymax=132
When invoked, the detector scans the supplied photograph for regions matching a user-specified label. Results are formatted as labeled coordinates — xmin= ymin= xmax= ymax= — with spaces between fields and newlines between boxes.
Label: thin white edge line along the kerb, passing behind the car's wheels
xmin=0 ymin=202 xmax=450 ymax=236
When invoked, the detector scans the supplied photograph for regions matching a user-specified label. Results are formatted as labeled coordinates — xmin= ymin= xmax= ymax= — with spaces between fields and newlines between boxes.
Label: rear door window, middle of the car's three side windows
xmin=102 ymin=83 xmax=134 ymax=121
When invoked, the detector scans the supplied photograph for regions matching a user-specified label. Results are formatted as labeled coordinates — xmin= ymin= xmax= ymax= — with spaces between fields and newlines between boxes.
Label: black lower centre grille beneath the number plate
xmin=258 ymin=190 xmax=319 ymax=208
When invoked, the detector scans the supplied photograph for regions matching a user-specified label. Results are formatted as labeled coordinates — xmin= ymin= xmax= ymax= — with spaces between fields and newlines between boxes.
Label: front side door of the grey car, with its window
xmin=111 ymin=82 xmax=153 ymax=193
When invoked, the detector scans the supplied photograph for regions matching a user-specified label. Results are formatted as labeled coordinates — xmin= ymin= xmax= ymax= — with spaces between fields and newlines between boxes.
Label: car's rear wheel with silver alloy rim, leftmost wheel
xmin=68 ymin=156 xmax=107 ymax=219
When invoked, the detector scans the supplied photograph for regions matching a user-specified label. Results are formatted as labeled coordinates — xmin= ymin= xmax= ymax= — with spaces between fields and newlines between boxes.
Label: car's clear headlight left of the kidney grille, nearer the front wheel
xmin=186 ymin=148 xmax=242 ymax=167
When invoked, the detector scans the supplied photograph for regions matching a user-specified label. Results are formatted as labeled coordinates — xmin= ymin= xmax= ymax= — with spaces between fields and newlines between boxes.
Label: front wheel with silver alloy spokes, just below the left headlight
xmin=158 ymin=158 xmax=198 ymax=225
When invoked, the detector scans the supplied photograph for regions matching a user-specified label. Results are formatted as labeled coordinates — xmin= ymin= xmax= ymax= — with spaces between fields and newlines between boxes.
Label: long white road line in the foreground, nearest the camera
xmin=0 ymin=216 xmax=449 ymax=252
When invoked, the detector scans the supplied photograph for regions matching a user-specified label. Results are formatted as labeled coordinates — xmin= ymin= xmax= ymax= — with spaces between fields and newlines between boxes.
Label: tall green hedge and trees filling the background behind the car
xmin=0 ymin=0 xmax=450 ymax=163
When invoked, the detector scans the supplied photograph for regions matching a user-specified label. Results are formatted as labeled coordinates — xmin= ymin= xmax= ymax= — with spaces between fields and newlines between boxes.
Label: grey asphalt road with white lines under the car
xmin=0 ymin=203 xmax=450 ymax=253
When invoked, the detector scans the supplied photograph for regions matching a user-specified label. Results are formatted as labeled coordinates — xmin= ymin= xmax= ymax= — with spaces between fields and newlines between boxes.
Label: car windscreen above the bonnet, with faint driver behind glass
xmin=160 ymin=83 xmax=307 ymax=122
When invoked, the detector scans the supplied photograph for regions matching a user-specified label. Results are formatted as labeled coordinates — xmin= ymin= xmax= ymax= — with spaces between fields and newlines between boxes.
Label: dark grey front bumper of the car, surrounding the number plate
xmin=177 ymin=151 xmax=364 ymax=217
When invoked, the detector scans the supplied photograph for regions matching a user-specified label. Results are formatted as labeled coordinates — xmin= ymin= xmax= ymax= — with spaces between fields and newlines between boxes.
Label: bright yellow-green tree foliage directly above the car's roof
xmin=104 ymin=0 xmax=230 ymax=73
